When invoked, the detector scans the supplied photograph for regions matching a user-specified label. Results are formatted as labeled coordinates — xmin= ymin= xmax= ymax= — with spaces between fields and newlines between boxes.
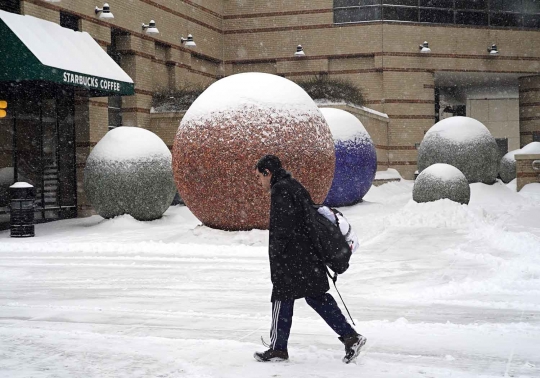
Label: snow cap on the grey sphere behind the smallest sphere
xmin=424 ymin=116 xmax=491 ymax=142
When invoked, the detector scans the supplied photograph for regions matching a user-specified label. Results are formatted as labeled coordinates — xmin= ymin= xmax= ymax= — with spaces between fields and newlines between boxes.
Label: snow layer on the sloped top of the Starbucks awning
xmin=0 ymin=10 xmax=133 ymax=83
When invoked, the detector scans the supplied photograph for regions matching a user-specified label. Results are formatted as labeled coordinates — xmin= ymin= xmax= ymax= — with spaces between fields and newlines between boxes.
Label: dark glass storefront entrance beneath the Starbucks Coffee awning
xmin=0 ymin=83 xmax=77 ymax=228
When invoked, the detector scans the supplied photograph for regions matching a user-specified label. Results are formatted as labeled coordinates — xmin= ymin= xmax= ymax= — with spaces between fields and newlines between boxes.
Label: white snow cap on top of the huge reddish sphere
xmin=182 ymin=72 xmax=318 ymax=124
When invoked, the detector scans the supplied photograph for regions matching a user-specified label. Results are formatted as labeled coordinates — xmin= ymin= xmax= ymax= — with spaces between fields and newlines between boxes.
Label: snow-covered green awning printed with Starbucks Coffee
xmin=0 ymin=11 xmax=134 ymax=96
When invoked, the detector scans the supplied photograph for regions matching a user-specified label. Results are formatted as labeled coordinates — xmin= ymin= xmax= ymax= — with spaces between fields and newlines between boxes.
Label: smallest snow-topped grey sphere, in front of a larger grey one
xmin=413 ymin=163 xmax=471 ymax=205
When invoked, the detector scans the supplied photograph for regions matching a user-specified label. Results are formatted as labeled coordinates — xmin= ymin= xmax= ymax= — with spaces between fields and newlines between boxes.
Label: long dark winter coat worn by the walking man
xmin=269 ymin=169 xmax=330 ymax=301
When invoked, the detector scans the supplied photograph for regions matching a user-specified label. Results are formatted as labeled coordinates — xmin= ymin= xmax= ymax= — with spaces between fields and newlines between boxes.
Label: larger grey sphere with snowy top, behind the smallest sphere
xmin=418 ymin=117 xmax=500 ymax=184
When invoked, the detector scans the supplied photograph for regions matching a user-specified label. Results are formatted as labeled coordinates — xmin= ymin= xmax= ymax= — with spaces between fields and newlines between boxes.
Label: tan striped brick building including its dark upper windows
xmin=0 ymin=0 xmax=540 ymax=227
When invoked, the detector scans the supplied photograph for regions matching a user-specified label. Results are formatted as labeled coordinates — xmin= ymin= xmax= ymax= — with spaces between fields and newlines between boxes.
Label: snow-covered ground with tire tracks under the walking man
xmin=0 ymin=181 xmax=540 ymax=378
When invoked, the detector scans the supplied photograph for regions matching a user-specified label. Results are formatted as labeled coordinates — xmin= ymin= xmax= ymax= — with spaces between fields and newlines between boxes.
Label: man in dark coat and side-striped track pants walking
xmin=253 ymin=155 xmax=367 ymax=363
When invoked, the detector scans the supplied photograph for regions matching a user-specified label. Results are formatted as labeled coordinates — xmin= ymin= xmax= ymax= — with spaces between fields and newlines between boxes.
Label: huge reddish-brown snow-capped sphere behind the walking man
xmin=173 ymin=73 xmax=335 ymax=230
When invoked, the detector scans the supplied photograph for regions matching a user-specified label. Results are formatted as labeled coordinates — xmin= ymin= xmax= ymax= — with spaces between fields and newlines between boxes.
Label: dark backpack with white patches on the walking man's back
xmin=313 ymin=205 xmax=358 ymax=274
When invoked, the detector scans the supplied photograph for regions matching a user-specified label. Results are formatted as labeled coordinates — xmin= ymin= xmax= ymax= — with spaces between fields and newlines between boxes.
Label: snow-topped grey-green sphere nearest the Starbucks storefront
xmin=84 ymin=126 xmax=176 ymax=221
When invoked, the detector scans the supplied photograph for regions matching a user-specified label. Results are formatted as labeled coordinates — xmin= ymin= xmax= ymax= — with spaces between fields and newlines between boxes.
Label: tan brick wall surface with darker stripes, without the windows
xmin=13 ymin=0 xmax=540 ymax=204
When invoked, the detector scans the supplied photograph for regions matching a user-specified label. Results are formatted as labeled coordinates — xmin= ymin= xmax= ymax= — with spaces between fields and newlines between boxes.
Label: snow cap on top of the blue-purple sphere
xmin=319 ymin=108 xmax=371 ymax=141
